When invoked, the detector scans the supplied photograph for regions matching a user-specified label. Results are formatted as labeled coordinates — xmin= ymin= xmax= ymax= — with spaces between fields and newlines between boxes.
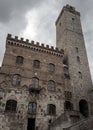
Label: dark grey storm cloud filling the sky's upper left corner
xmin=0 ymin=0 xmax=42 ymax=23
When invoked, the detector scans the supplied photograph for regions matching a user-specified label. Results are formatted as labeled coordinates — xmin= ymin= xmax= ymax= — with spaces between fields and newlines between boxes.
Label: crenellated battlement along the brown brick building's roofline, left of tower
xmin=6 ymin=34 xmax=64 ymax=56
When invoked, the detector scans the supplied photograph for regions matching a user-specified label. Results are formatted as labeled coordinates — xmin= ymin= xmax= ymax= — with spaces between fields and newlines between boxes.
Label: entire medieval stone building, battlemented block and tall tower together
xmin=0 ymin=5 xmax=93 ymax=130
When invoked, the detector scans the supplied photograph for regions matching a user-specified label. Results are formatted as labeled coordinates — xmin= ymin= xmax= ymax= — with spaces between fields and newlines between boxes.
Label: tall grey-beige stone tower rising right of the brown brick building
xmin=56 ymin=5 xmax=92 ymax=116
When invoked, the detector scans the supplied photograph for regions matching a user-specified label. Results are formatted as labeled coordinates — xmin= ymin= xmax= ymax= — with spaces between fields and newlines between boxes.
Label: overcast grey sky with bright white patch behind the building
xmin=0 ymin=0 xmax=93 ymax=79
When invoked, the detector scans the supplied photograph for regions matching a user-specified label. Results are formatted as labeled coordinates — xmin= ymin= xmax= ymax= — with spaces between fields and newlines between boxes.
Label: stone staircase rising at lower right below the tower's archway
xmin=48 ymin=111 xmax=93 ymax=130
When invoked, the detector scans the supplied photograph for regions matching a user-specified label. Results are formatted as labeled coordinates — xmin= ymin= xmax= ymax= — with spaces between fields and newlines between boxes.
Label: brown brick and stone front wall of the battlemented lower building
xmin=0 ymin=35 xmax=64 ymax=130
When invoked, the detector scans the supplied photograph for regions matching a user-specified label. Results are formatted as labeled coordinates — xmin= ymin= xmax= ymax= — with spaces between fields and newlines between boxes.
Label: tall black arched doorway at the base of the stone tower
xmin=79 ymin=99 xmax=89 ymax=117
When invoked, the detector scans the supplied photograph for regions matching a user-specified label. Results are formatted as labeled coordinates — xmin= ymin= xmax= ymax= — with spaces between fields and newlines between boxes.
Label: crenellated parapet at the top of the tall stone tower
xmin=56 ymin=4 xmax=80 ymax=25
